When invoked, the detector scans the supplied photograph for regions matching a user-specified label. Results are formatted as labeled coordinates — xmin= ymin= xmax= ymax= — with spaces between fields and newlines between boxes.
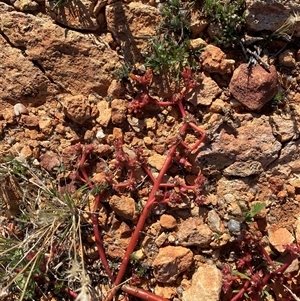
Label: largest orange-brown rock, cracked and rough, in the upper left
xmin=0 ymin=2 xmax=120 ymax=99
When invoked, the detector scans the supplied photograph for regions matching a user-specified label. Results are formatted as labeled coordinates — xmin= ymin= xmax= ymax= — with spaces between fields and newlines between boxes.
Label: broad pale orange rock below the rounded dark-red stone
xmin=198 ymin=114 xmax=281 ymax=170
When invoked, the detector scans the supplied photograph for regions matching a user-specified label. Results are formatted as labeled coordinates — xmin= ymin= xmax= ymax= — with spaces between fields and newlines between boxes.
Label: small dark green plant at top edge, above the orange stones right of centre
xmin=203 ymin=0 xmax=245 ymax=46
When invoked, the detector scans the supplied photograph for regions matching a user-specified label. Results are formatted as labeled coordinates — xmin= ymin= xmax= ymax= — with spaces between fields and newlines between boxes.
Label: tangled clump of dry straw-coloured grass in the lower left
xmin=0 ymin=158 xmax=91 ymax=301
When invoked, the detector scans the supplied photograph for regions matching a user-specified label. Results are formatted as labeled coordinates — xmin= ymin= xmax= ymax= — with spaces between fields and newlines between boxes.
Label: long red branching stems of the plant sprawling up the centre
xmin=79 ymin=70 xmax=205 ymax=301
